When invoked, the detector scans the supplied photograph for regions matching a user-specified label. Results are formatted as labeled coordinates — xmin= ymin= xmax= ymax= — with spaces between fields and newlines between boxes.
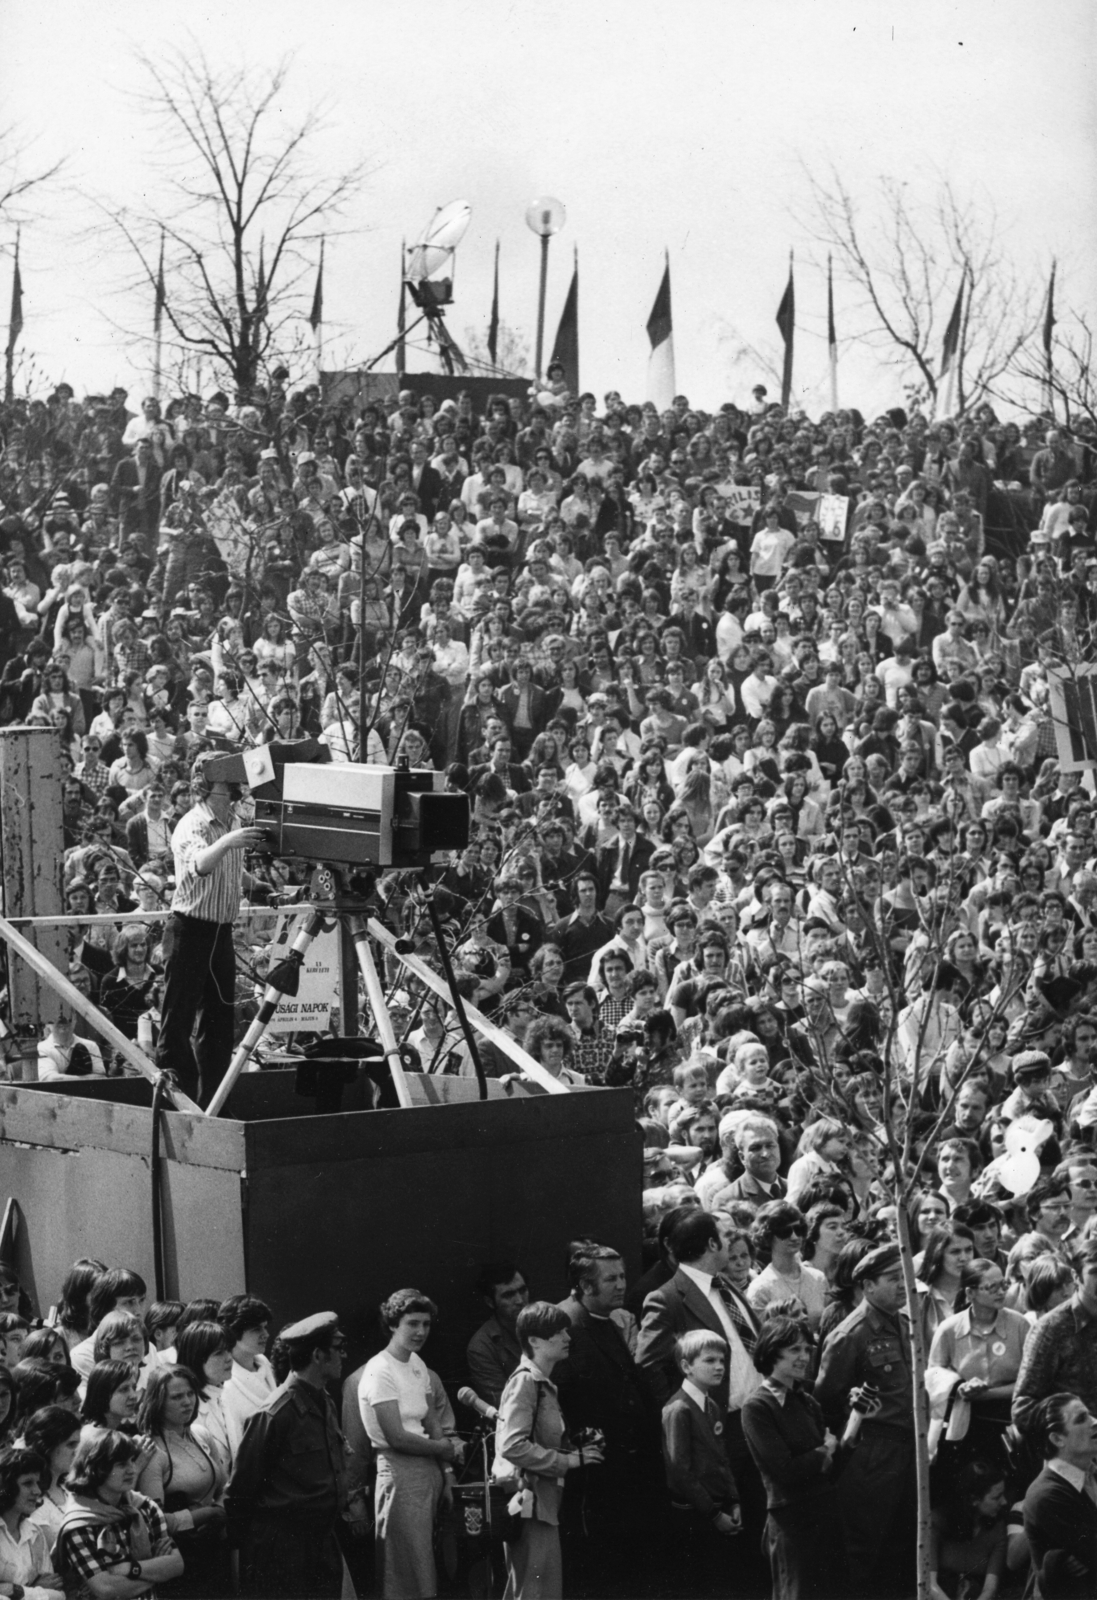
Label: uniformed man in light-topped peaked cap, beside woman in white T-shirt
xmin=225 ymin=1310 xmax=365 ymax=1600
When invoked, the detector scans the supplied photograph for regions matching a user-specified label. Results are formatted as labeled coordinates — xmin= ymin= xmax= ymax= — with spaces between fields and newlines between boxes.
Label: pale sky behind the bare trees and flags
xmin=0 ymin=0 xmax=1097 ymax=413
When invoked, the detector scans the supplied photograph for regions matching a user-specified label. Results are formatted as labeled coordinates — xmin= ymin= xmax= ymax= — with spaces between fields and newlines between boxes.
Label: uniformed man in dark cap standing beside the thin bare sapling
xmin=816 ymin=1245 xmax=921 ymax=1600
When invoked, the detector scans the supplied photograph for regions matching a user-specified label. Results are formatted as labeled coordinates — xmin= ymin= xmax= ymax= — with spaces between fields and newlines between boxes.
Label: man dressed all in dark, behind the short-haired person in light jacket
xmin=555 ymin=1245 xmax=664 ymax=1597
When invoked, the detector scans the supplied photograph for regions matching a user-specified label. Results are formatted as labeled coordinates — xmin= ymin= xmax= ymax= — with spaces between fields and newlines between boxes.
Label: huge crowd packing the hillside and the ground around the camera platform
xmin=0 ymin=368 xmax=1097 ymax=1600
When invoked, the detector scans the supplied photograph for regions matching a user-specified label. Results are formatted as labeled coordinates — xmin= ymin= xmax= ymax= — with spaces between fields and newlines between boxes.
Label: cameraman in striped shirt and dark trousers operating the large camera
xmin=157 ymin=752 xmax=265 ymax=1106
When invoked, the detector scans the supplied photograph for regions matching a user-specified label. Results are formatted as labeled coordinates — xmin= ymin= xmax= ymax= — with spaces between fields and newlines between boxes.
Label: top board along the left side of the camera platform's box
xmin=0 ymin=1085 xmax=245 ymax=1173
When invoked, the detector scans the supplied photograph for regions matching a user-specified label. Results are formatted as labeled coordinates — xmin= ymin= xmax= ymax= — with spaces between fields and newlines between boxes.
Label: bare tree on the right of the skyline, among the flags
xmin=806 ymin=168 xmax=1039 ymax=413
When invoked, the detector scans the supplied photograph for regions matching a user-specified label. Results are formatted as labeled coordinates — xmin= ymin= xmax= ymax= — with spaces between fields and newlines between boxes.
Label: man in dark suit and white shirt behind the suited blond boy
xmin=636 ymin=1211 xmax=766 ymax=1565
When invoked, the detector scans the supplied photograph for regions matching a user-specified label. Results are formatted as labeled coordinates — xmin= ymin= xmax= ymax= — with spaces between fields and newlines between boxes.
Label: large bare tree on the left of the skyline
xmin=112 ymin=45 xmax=366 ymax=389
